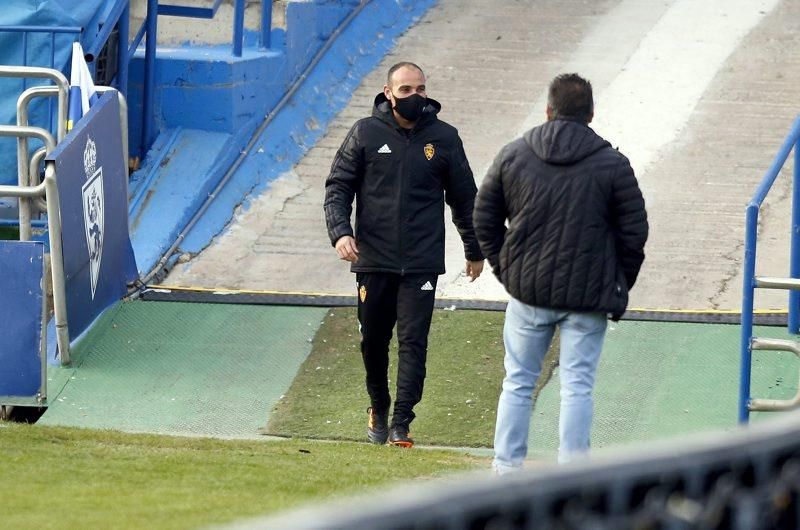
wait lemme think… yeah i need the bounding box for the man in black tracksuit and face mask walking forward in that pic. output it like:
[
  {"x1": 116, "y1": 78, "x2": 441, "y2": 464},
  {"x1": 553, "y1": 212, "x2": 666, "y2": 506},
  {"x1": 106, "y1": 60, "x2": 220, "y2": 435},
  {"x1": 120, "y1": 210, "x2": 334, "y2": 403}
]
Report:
[{"x1": 324, "y1": 62, "x2": 483, "y2": 447}]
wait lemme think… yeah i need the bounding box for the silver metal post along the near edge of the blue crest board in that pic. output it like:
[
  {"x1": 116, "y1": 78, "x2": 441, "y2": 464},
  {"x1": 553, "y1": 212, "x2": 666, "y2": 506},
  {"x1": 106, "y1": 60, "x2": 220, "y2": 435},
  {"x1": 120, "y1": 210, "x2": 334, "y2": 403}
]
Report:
[{"x1": 44, "y1": 161, "x2": 70, "y2": 365}]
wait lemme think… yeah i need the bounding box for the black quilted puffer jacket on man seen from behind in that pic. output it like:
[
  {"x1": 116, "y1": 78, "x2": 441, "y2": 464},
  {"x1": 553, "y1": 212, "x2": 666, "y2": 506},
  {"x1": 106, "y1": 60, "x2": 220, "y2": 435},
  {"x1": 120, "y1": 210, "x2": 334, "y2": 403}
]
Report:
[{"x1": 474, "y1": 119, "x2": 648, "y2": 319}]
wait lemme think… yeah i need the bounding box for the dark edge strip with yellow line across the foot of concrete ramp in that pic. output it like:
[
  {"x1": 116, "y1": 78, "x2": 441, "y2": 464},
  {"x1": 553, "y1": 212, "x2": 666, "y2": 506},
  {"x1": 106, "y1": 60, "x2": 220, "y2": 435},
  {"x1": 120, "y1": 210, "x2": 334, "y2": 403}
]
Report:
[{"x1": 140, "y1": 287, "x2": 787, "y2": 326}]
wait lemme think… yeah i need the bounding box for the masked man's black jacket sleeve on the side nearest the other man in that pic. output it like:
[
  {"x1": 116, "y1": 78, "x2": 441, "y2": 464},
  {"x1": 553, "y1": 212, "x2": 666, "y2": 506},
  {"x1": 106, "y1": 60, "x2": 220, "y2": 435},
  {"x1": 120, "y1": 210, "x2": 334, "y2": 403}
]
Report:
[{"x1": 444, "y1": 134, "x2": 483, "y2": 261}]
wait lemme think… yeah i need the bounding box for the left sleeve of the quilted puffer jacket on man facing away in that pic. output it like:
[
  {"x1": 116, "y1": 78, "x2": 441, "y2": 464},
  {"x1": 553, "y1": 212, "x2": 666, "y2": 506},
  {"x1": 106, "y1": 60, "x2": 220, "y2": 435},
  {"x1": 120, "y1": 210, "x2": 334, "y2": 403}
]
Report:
[{"x1": 473, "y1": 144, "x2": 508, "y2": 278}]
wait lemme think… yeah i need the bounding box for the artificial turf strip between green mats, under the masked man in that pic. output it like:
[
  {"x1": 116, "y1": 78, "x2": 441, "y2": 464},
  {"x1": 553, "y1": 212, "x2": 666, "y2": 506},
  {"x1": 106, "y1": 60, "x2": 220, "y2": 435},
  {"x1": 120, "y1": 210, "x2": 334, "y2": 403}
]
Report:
[{"x1": 267, "y1": 308, "x2": 554, "y2": 447}]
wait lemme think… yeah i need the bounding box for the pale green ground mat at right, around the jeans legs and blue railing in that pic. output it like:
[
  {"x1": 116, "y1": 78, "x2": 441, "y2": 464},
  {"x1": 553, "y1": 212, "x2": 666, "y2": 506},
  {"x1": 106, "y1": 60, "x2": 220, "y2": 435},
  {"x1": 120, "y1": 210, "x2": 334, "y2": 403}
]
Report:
[{"x1": 530, "y1": 321, "x2": 800, "y2": 458}]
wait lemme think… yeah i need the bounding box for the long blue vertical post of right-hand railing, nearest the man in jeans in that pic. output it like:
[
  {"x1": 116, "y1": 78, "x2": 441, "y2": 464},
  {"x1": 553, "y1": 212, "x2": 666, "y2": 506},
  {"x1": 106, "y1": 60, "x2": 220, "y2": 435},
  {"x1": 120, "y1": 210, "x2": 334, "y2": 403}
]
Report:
[{"x1": 739, "y1": 202, "x2": 758, "y2": 423}]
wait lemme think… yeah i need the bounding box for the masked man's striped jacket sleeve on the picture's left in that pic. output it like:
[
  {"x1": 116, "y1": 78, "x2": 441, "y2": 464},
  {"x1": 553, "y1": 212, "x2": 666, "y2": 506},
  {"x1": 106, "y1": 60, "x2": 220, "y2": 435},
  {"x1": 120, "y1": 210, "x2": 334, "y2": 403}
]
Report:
[{"x1": 323, "y1": 122, "x2": 364, "y2": 246}]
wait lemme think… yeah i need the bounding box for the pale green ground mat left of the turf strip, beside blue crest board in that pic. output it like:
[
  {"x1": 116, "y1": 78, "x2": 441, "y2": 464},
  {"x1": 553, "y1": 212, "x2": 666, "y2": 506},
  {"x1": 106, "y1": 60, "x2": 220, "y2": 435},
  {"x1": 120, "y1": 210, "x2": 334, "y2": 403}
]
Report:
[{"x1": 40, "y1": 301, "x2": 327, "y2": 438}]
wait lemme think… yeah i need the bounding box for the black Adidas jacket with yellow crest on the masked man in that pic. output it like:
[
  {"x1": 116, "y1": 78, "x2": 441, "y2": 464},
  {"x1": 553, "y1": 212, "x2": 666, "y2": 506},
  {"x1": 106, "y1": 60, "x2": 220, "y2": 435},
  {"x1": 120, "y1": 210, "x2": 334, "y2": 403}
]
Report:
[{"x1": 324, "y1": 93, "x2": 483, "y2": 274}]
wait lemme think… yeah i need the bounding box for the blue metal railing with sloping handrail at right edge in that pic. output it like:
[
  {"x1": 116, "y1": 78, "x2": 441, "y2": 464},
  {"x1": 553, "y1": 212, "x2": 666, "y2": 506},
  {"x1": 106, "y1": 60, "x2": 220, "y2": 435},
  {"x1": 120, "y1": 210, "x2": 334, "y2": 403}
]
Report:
[{"x1": 739, "y1": 117, "x2": 800, "y2": 423}]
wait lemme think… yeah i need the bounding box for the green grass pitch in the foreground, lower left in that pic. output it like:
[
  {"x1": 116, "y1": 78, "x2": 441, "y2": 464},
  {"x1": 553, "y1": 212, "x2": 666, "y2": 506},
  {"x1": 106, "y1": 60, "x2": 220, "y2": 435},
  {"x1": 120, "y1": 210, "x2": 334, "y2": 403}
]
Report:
[{"x1": 0, "y1": 423, "x2": 489, "y2": 528}]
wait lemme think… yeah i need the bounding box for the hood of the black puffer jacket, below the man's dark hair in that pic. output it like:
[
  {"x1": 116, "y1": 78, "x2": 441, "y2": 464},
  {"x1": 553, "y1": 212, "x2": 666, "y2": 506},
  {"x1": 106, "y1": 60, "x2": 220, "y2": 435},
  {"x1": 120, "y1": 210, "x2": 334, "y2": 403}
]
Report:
[{"x1": 523, "y1": 119, "x2": 611, "y2": 165}]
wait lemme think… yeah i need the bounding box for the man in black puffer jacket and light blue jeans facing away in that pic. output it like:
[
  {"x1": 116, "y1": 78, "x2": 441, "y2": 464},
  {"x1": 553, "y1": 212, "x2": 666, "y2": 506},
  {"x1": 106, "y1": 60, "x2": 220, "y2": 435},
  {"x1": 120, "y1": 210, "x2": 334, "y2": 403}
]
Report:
[{"x1": 474, "y1": 74, "x2": 648, "y2": 474}]
